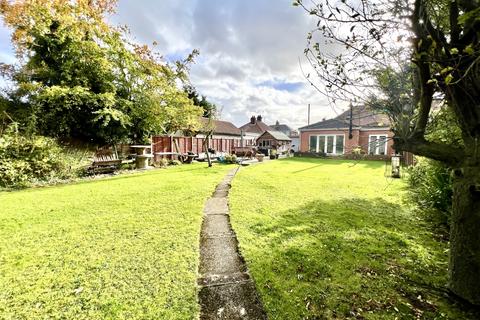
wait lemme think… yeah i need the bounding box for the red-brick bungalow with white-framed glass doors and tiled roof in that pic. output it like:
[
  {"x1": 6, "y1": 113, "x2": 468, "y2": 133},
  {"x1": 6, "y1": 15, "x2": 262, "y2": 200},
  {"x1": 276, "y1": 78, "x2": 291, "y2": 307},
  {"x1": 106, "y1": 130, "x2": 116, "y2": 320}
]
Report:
[{"x1": 299, "y1": 106, "x2": 394, "y2": 158}]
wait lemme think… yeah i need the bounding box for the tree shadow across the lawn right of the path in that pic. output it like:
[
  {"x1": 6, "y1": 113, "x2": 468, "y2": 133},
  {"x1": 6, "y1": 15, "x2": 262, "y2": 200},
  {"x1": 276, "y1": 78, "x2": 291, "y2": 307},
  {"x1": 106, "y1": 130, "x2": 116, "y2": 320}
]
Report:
[{"x1": 240, "y1": 198, "x2": 480, "y2": 319}]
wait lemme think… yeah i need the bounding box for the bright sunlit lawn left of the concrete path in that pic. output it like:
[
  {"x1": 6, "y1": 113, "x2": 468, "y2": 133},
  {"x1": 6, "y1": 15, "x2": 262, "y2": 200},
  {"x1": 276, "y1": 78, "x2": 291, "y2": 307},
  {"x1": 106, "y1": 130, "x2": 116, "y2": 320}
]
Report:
[{"x1": 0, "y1": 164, "x2": 230, "y2": 319}]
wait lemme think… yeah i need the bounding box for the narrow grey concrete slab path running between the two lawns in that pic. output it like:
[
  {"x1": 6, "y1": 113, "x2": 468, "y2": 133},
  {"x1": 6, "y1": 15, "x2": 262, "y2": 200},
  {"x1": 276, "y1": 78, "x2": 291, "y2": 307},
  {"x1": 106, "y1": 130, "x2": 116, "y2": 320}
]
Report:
[{"x1": 198, "y1": 168, "x2": 267, "y2": 320}]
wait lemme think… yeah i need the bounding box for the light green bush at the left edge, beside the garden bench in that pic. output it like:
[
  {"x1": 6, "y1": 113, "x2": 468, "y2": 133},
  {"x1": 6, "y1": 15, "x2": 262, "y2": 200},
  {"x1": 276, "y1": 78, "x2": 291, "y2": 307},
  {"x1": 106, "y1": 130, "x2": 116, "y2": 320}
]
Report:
[{"x1": 0, "y1": 124, "x2": 85, "y2": 188}]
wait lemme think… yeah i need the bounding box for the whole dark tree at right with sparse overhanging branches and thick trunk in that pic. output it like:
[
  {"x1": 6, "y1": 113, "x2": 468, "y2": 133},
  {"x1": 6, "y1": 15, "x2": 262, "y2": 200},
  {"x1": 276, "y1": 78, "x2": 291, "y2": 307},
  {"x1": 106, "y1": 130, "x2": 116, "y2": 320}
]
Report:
[{"x1": 294, "y1": 0, "x2": 480, "y2": 305}]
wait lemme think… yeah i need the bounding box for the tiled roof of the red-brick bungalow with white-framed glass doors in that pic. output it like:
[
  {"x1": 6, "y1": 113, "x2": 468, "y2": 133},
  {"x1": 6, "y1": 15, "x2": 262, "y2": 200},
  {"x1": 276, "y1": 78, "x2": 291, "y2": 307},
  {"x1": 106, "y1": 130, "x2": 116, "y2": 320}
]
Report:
[{"x1": 300, "y1": 106, "x2": 390, "y2": 130}]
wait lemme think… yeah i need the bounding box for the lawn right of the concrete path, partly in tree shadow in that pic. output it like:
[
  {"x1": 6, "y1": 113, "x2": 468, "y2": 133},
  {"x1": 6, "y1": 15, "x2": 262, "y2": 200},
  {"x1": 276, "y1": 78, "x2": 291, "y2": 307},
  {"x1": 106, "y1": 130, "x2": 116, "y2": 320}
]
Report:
[{"x1": 230, "y1": 159, "x2": 479, "y2": 319}]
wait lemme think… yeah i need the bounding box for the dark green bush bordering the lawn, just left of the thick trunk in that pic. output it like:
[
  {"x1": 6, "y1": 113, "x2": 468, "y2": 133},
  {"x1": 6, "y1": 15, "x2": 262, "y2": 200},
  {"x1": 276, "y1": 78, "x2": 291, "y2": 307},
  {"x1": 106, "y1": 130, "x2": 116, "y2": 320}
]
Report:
[{"x1": 407, "y1": 158, "x2": 453, "y2": 225}]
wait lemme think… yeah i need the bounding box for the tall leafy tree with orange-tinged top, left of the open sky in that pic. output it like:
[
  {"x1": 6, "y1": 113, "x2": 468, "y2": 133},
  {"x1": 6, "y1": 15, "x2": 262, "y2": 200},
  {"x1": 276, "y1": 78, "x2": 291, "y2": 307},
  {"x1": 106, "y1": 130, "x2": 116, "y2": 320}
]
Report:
[{"x1": 0, "y1": 0, "x2": 200, "y2": 144}]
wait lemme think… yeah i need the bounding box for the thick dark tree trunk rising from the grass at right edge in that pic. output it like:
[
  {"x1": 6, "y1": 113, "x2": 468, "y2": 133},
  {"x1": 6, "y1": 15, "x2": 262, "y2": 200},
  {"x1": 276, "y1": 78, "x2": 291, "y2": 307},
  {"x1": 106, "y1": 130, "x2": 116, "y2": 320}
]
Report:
[{"x1": 449, "y1": 165, "x2": 480, "y2": 305}]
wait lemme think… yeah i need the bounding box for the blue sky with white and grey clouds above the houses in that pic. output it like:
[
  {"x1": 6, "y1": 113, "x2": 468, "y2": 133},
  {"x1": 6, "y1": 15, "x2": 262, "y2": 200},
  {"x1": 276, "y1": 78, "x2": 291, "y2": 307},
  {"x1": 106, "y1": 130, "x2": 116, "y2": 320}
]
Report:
[{"x1": 0, "y1": 0, "x2": 342, "y2": 129}]
